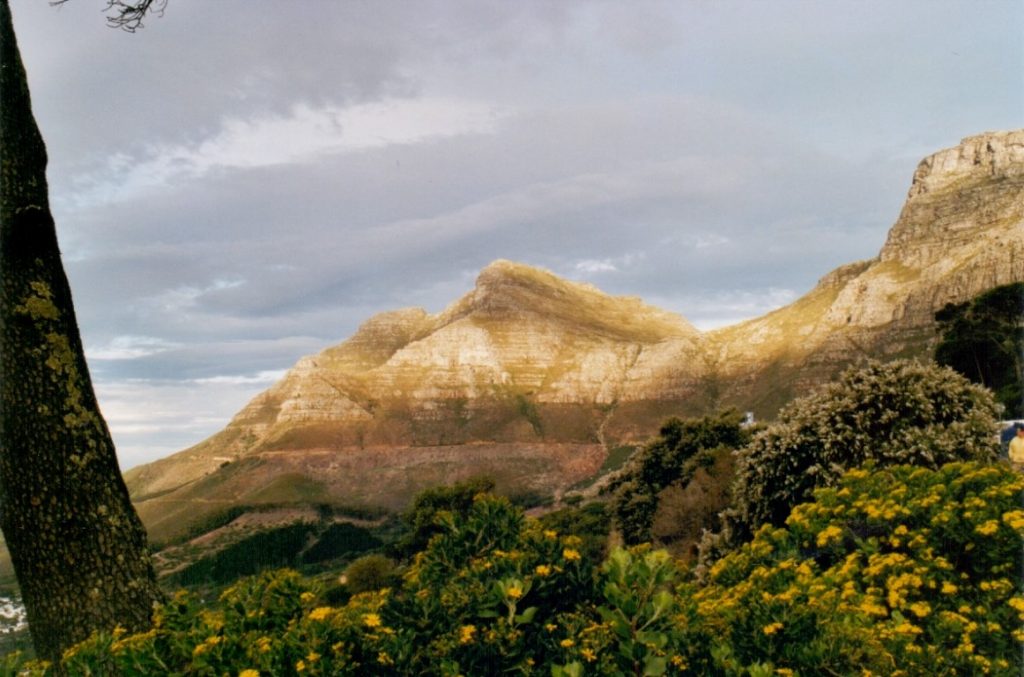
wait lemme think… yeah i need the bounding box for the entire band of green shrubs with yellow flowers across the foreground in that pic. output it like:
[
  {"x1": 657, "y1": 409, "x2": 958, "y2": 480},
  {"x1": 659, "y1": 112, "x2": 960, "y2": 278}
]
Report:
[{"x1": 7, "y1": 463, "x2": 1024, "y2": 677}]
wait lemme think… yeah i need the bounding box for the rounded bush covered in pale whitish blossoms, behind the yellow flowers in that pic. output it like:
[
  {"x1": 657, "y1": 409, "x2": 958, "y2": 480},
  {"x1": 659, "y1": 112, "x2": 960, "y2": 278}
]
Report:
[{"x1": 727, "y1": 361, "x2": 998, "y2": 543}]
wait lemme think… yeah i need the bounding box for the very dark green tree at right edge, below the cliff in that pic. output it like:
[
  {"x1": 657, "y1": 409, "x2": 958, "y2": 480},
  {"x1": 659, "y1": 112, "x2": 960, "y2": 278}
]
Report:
[{"x1": 935, "y1": 283, "x2": 1024, "y2": 418}]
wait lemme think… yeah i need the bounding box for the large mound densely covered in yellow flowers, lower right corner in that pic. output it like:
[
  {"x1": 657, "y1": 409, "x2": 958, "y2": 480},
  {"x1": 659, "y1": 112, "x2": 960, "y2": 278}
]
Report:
[{"x1": 687, "y1": 463, "x2": 1024, "y2": 675}]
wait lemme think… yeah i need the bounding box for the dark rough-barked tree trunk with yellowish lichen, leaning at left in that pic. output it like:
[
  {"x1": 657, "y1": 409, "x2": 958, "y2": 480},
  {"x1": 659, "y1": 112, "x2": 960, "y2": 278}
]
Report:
[{"x1": 0, "y1": 0, "x2": 161, "y2": 662}]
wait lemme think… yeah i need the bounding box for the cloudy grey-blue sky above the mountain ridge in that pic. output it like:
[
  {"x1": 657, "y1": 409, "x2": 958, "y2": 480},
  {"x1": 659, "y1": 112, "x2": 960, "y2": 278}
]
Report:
[{"x1": 11, "y1": 0, "x2": 1024, "y2": 467}]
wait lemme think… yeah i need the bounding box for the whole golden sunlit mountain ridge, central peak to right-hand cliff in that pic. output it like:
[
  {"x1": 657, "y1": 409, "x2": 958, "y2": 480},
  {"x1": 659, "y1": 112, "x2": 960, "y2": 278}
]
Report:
[{"x1": 126, "y1": 130, "x2": 1024, "y2": 542}]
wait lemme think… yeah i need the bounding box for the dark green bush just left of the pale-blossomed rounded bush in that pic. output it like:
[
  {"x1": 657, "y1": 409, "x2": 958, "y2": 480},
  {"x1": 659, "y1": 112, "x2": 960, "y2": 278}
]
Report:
[{"x1": 609, "y1": 410, "x2": 750, "y2": 545}]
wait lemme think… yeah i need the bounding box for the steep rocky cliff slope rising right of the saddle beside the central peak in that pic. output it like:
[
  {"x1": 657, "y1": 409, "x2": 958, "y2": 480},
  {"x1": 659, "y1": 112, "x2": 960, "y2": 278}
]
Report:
[{"x1": 708, "y1": 130, "x2": 1024, "y2": 415}]
